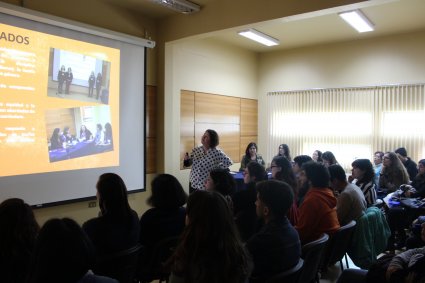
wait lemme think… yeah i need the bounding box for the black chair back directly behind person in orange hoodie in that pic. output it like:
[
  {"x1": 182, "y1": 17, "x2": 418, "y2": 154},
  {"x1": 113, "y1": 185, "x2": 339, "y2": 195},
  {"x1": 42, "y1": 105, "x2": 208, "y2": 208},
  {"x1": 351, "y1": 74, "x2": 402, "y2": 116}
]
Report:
[{"x1": 298, "y1": 233, "x2": 329, "y2": 283}]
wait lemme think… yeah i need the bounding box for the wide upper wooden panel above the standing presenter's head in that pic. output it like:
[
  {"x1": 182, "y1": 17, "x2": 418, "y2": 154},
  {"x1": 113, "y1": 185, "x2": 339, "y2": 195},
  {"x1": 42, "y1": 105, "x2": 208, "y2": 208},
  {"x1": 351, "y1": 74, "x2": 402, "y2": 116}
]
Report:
[{"x1": 195, "y1": 92, "x2": 240, "y2": 124}]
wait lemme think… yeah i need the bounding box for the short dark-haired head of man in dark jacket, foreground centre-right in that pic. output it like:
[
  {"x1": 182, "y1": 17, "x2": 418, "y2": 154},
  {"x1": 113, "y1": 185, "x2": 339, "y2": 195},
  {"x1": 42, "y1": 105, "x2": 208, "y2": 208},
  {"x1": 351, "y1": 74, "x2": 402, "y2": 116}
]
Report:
[{"x1": 255, "y1": 180, "x2": 294, "y2": 223}]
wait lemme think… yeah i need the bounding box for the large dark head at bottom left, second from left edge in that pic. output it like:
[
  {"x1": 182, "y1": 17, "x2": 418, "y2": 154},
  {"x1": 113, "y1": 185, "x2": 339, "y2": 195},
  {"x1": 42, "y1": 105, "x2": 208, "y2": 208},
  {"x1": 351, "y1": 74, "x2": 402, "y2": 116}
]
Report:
[{"x1": 29, "y1": 218, "x2": 94, "y2": 283}]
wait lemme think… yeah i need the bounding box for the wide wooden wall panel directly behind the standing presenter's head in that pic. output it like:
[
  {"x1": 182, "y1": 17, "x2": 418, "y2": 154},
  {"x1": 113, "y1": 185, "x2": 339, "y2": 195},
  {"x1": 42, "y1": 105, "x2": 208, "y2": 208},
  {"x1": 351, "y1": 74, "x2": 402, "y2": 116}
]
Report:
[{"x1": 195, "y1": 123, "x2": 240, "y2": 162}]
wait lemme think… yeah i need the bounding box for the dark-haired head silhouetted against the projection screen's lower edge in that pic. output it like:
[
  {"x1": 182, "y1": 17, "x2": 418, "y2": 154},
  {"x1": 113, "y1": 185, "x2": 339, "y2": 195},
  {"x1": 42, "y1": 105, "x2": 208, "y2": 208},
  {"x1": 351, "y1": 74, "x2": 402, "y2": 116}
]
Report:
[{"x1": 96, "y1": 173, "x2": 131, "y2": 216}]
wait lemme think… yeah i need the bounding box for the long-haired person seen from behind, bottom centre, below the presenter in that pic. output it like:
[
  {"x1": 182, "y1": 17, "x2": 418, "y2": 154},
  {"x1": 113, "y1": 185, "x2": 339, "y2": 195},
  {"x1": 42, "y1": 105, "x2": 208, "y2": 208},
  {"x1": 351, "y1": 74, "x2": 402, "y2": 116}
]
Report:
[{"x1": 167, "y1": 190, "x2": 251, "y2": 283}]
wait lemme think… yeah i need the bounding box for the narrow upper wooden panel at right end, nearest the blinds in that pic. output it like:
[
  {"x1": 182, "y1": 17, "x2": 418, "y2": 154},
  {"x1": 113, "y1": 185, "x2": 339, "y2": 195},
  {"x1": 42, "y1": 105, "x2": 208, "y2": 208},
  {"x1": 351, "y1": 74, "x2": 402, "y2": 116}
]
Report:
[{"x1": 241, "y1": 98, "x2": 258, "y2": 136}]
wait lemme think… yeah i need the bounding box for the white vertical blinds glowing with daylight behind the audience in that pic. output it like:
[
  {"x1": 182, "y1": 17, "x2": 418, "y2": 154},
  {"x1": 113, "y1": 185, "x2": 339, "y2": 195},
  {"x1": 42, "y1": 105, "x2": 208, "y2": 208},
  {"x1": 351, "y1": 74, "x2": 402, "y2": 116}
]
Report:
[{"x1": 267, "y1": 84, "x2": 425, "y2": 170}]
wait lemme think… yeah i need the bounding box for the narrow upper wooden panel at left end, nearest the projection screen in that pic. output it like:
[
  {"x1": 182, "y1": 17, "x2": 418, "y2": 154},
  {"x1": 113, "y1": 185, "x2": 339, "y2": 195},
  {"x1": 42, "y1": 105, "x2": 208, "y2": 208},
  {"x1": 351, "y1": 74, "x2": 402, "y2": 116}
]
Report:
[{"x1": 180, "y1": 90, "x2": 195, "y2": 136}]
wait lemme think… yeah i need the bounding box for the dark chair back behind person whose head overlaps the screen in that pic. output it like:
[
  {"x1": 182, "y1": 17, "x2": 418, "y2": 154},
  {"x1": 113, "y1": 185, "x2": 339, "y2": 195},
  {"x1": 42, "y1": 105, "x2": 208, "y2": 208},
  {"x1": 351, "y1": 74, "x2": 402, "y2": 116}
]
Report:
[{"x1": 93, "y1": 244, "x2": 142, "y2": 283}]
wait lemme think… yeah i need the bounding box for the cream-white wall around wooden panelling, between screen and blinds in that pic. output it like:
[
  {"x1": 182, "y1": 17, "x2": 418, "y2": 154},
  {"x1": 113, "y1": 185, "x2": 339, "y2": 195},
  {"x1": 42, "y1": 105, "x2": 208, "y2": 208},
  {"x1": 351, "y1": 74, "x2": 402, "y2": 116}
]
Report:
[{"x1": 164, "y1": 39, "x2": 258, "y2": 189}]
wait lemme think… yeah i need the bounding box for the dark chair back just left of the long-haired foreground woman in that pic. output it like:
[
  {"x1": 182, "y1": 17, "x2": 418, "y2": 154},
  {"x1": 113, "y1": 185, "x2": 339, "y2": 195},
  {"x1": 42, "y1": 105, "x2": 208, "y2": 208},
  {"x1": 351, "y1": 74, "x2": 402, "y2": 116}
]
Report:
[{"x1": 137, "y1": 236, "x2": 180, "y2": 283}]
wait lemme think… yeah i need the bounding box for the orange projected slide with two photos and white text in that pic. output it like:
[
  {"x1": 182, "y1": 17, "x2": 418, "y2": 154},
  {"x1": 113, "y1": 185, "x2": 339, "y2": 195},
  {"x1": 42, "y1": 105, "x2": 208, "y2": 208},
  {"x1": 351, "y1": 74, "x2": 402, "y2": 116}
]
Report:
[{"x1": 0, "y1": 24, "x2": 120, "y2": 176}]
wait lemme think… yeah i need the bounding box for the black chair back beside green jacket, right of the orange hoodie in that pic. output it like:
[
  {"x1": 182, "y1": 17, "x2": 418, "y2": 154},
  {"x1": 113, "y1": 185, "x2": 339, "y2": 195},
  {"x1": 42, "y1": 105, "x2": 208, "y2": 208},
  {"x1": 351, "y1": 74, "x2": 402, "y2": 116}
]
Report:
[{"x1": 323, "y1": 220, "x2": 356, "y2": 271}]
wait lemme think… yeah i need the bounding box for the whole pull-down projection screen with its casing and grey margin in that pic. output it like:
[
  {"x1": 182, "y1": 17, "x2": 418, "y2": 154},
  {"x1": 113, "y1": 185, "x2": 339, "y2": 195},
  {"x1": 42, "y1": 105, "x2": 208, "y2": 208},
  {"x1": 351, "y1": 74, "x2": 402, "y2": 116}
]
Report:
[{"x1": 0, "y1": 3, "x2": 155, "y2": 207}]
